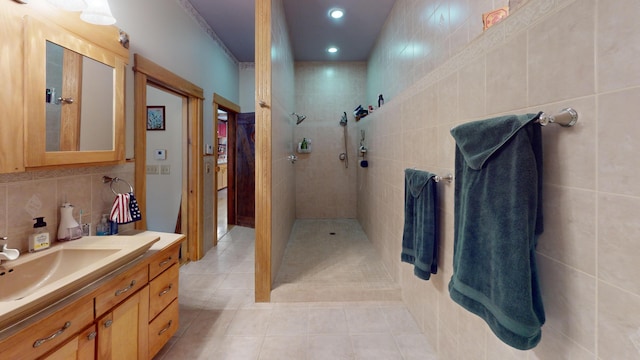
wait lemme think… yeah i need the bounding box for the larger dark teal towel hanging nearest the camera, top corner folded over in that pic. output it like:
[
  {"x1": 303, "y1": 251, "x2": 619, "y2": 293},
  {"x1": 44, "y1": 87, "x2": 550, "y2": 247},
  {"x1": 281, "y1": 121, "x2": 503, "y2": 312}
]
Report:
[{"x1": 449, "y1": 114, "x2": 545, "y2": 350}]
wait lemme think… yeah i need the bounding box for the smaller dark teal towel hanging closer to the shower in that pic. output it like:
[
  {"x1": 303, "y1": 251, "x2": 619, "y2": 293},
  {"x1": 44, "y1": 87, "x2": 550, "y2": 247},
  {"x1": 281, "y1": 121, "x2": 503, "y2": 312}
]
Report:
[{"x1": 400, "y1": 169, "x2": 438, "y2": 280}]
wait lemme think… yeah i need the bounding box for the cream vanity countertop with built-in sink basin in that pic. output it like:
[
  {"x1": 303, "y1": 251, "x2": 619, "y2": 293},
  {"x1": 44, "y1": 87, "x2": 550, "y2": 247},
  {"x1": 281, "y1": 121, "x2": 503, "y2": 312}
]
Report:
[{"x1": 0, "y1": 235, "x2": 159, "y2": 329}]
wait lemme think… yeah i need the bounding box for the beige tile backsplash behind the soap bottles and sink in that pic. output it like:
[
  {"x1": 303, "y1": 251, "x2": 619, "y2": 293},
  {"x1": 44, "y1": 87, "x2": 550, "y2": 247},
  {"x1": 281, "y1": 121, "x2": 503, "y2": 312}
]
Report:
[{"x1": 0, "y1": 163, "x2": 135, "y2": 252}]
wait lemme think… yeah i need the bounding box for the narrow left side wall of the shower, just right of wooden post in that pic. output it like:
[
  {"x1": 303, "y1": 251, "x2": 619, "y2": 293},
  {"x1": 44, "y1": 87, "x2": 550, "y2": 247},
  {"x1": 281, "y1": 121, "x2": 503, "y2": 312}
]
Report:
[{"x1": 270, "y1": 0, "x2": 296, "y2": 282}]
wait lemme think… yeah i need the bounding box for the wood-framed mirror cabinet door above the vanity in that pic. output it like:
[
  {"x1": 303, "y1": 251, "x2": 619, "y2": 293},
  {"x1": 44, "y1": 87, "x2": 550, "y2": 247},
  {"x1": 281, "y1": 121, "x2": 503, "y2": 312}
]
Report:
[{"x1": 24, "y1": 16, "x2": 128, "y2": 167}]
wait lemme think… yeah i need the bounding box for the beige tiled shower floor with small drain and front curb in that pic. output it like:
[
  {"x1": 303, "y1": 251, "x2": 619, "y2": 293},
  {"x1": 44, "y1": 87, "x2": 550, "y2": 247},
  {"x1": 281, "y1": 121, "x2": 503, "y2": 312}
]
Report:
[{"x1": 271, "y1": 219, "x2": 401, "y2": 302}]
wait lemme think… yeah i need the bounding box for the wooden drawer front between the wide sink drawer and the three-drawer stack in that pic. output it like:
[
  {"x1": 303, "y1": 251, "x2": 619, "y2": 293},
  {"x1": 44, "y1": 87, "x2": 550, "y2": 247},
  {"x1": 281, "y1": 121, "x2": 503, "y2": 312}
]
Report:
[{"x1": 95, "y1": 267, "x2": 149, "y2": 318}]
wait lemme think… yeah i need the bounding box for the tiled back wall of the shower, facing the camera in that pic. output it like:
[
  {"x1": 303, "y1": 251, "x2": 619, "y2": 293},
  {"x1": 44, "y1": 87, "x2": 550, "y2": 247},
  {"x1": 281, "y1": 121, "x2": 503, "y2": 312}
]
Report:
[{"x1": 294, "y1": 62, "x2": 367, "y2": 219}]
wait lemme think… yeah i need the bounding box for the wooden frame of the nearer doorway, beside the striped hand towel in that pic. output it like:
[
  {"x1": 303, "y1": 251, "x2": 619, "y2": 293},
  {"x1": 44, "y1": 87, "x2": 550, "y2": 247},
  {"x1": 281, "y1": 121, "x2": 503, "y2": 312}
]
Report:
[{"x1": 133, "y1": 54, "x2": 204, "y2": 260}]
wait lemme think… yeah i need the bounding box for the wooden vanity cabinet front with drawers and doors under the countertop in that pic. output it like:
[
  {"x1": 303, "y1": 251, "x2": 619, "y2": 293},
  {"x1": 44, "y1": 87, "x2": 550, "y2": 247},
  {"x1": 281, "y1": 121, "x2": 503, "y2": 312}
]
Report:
[{"x1": 0, "y1": 237, "x2": 184, "y2": 360}]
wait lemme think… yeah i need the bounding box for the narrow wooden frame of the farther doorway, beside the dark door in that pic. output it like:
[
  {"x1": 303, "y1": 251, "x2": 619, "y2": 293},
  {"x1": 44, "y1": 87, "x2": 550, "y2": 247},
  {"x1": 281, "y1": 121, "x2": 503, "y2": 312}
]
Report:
[{"x1": 213, "y1": 93, "x2": 240, "y2": 246}]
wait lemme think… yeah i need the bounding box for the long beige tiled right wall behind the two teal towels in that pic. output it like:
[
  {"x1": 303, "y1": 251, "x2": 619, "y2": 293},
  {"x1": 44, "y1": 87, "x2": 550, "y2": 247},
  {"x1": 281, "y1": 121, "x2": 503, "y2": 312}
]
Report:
[{"x1": 357, "y1": 0, "x2": 640, "y2": 359}]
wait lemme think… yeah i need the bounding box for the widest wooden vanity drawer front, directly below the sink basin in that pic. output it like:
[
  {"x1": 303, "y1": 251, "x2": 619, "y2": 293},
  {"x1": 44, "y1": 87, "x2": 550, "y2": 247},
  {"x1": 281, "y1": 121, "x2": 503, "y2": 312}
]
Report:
[{"x1": 0, "y1": 299, "x2": 93, "y2": 359}]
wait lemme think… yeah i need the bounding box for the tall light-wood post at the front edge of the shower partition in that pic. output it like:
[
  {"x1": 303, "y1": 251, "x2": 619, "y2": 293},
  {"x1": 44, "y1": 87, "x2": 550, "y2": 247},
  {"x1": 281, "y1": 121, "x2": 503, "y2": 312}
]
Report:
[{"x1": 255, "y1": 1, "x2": 272, "y2": 302}]
